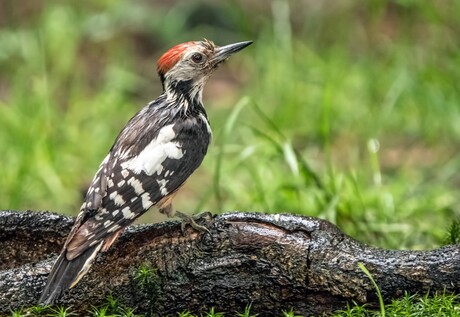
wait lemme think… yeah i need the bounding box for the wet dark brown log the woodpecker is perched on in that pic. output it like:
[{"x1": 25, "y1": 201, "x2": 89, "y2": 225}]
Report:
[{"x1": 0, "y1": 211, "x2": 460, "y2": 316}]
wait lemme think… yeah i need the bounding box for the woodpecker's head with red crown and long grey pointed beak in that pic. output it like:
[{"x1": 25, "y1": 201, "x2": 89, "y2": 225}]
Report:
[{"x1": 157, "y1": 39, "x2": 252, "y2": 99}]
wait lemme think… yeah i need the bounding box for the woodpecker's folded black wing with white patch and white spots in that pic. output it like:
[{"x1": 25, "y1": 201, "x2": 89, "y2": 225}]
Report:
[{"x1": 67, "y1": 118, "x2": 209, "y2": 258}]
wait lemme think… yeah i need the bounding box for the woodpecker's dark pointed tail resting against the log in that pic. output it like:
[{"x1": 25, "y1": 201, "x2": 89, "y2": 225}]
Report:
[{"x1": 38, "y1": 242, "x2": 102, "y2": 305}]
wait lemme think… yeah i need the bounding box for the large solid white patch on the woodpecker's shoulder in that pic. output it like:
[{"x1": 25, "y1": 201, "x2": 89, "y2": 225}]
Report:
[{"x1": 122, "y1": 124, "x2": 184, "y2": 176}]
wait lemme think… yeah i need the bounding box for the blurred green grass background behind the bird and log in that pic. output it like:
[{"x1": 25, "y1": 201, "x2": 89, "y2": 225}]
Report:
[{"x1": 0, "y1": 0, "x2": 460, "y2": 249}]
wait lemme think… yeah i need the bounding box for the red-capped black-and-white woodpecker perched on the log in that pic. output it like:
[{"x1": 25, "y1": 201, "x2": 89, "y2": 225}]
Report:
[{"x1": 39, "y1": 39, "x2": 252, "y2": 305}]
